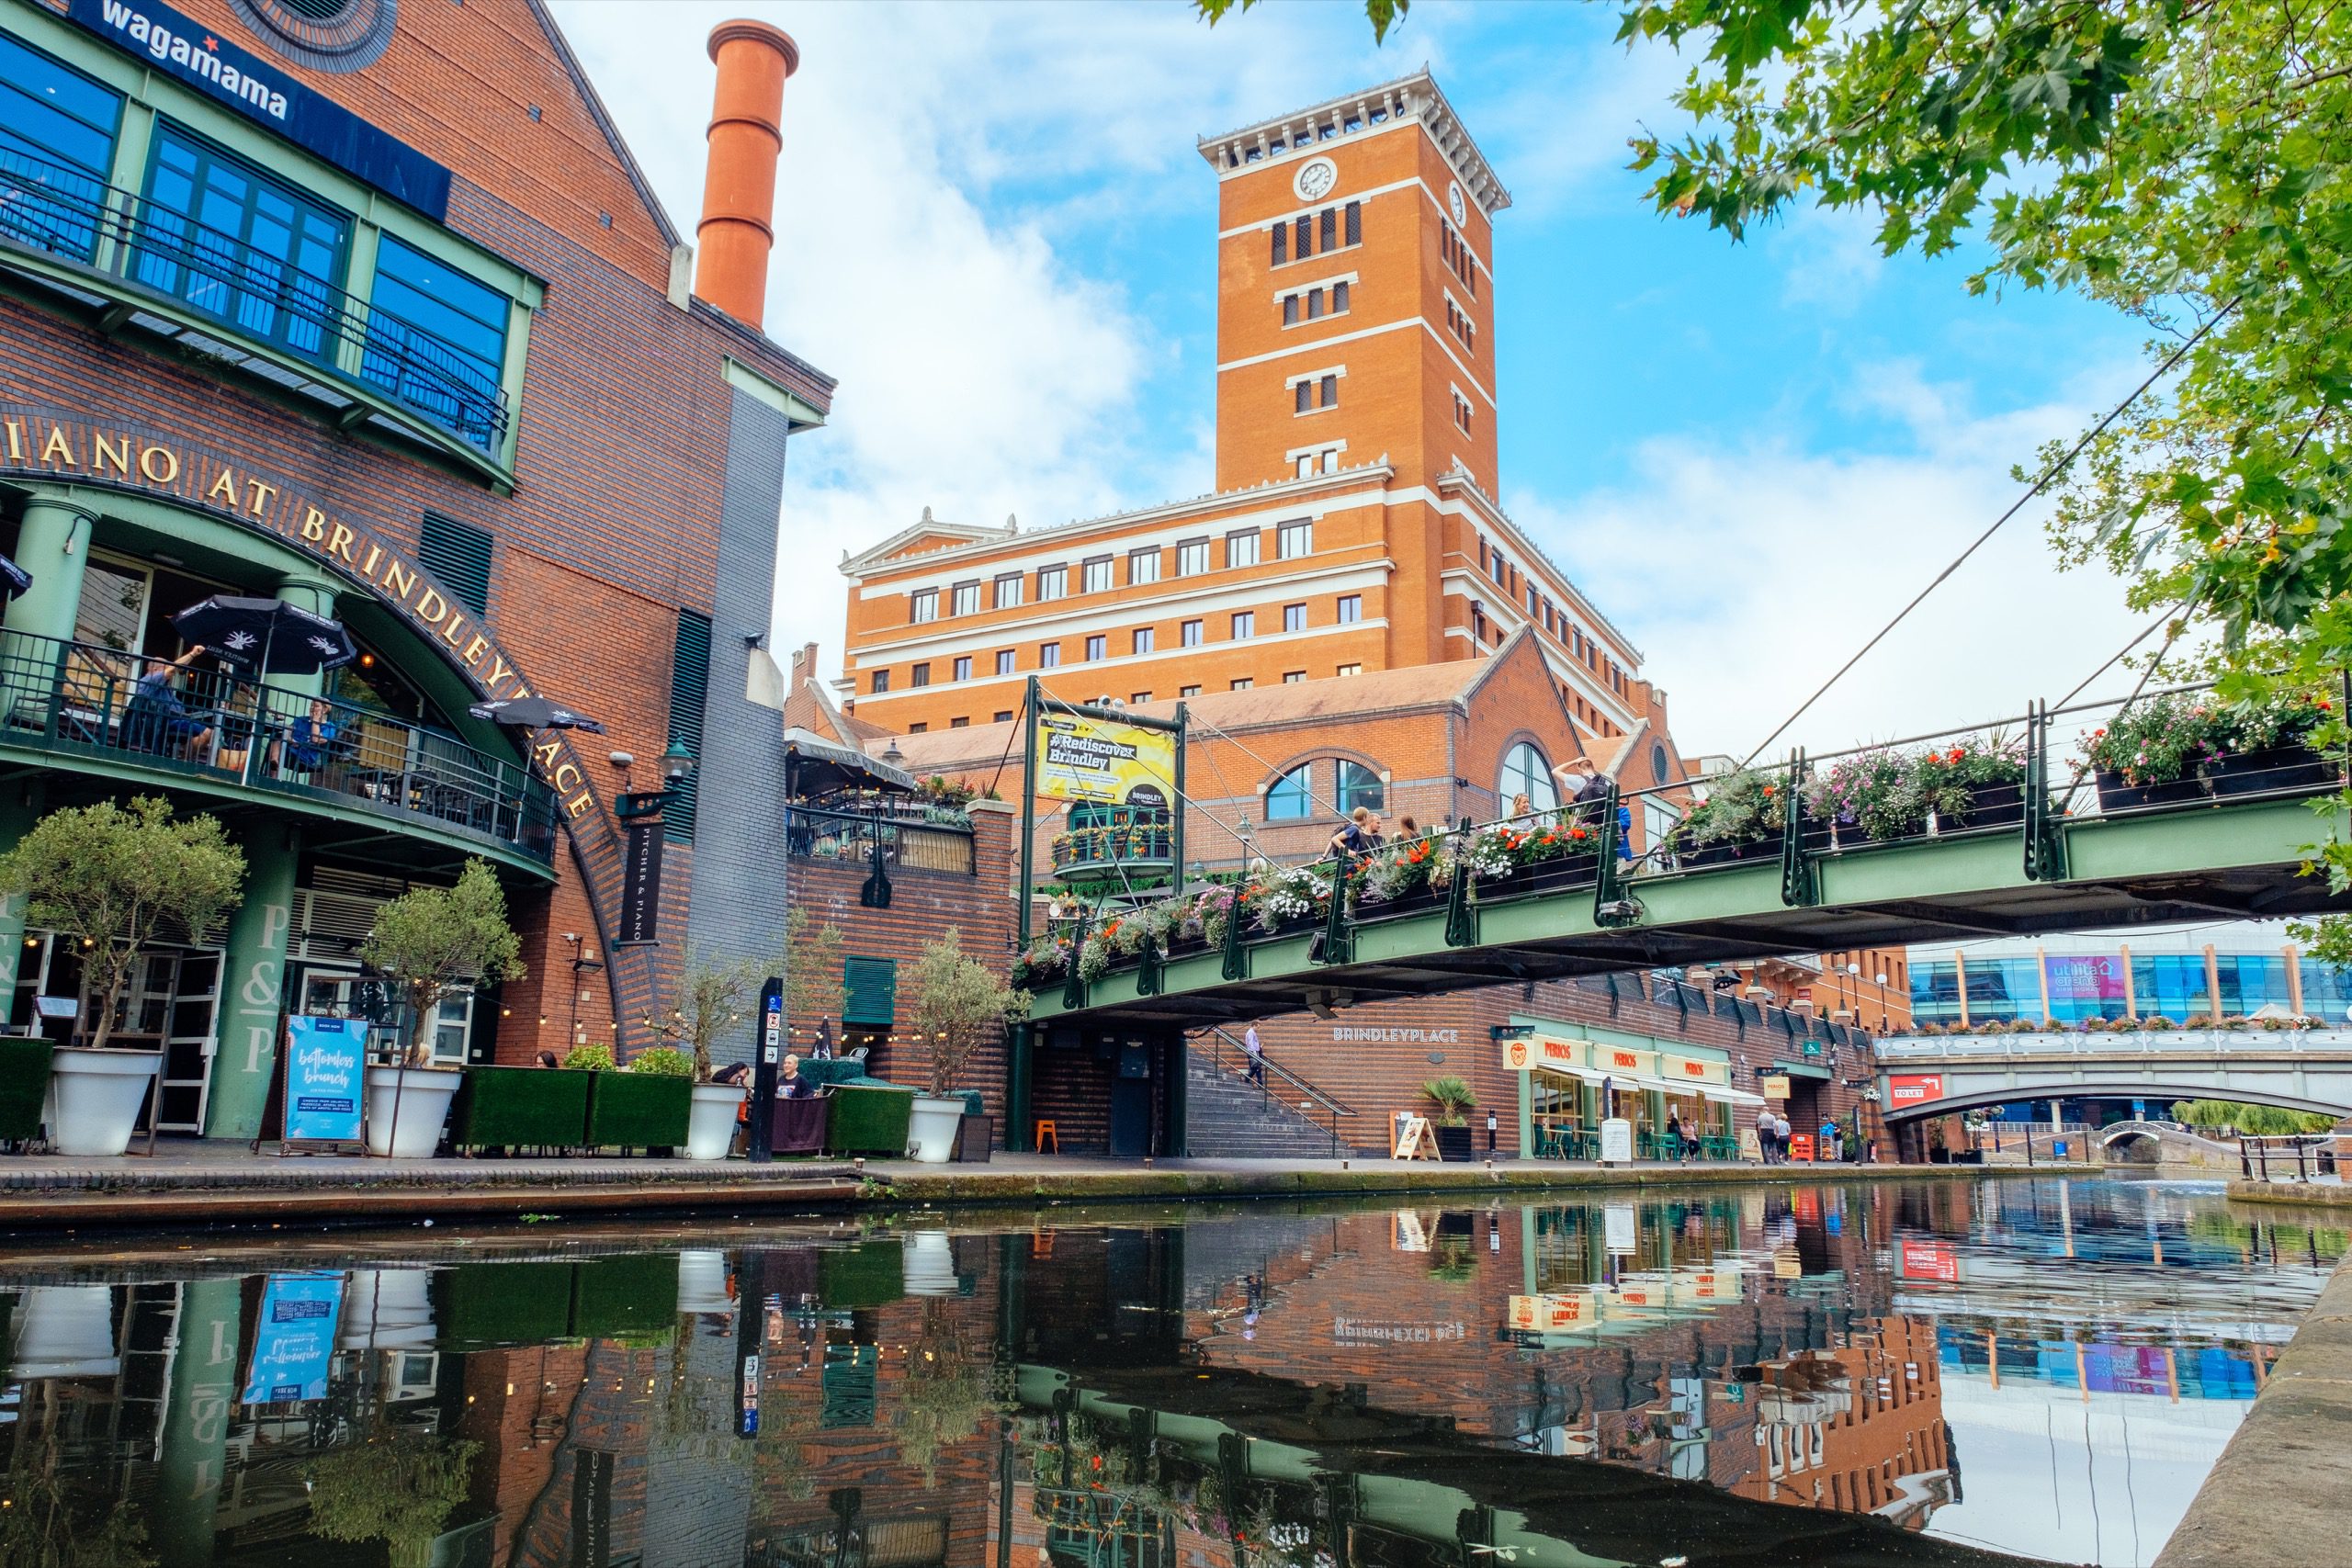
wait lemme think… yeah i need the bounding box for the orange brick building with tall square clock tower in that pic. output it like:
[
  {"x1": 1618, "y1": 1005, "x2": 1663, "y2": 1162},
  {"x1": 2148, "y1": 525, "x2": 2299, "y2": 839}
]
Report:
[{"x1": 842, "y1": 73, "x2": 1665, "y2": 761}]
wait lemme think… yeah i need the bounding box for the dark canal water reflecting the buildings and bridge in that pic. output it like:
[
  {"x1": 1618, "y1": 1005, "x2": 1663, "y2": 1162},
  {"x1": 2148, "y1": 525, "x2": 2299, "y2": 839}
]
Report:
[{"x1": 0, "y1": 1180, "x2": 2345, "y2": 1568}]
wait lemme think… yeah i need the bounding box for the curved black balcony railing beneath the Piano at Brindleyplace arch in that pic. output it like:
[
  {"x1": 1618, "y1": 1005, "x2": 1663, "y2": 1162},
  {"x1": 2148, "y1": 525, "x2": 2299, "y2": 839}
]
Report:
[{"x1": 0, "y1": 632, "x2": 555, "y2": 863}]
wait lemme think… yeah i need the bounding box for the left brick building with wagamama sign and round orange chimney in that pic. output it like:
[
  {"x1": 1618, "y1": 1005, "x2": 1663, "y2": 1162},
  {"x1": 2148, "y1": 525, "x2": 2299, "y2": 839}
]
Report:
[{"x1": 0, "y1": 0, "x2": 832, "y2": 1138}]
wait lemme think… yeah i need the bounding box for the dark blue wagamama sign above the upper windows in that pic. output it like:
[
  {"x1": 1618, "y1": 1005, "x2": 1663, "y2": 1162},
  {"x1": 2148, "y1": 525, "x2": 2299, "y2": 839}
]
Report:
[{"x1": 66, "y1": 0, "x2": 449, "y2": 223}]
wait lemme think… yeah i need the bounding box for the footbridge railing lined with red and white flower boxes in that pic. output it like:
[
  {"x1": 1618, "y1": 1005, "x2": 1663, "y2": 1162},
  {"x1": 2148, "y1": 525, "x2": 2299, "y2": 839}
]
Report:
[{"x1": 1018, "y1": 671, "x2": 2352, "y2": 991}]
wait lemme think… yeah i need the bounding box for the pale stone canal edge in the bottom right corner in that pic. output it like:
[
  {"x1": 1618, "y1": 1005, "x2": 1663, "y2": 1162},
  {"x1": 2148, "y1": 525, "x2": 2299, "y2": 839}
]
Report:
[{"x1": 2157, "y1": 1250, "x2": 2352, "y2": 1568}]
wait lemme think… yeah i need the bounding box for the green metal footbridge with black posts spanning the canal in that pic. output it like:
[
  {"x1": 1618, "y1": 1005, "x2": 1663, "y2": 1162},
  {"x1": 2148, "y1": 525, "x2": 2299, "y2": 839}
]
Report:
[{"x1": 1030, "y1": 710, "x2": 2352, "y2": 1032}]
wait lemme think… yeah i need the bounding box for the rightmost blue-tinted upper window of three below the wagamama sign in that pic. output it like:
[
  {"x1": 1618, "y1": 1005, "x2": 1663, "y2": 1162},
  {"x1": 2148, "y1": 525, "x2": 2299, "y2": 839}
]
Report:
[{"x1": 360, "y1": 235, "x2": 511, "y2": 446}]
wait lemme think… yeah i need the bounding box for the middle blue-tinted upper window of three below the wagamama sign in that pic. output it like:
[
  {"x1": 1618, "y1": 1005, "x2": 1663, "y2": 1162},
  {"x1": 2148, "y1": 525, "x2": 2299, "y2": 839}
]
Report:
[{"x1": 131, "y1": 125, "x2": 350, "y2": 360}]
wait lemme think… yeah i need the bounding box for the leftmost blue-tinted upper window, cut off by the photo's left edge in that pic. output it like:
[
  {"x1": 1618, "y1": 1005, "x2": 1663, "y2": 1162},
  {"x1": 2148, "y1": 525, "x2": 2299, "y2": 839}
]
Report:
[{"x1": 0, "y1": 33, "x2": 122, "y2": 261}]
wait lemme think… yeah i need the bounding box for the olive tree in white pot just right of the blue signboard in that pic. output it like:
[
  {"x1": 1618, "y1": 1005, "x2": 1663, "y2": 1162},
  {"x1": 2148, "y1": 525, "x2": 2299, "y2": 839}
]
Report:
[{"x1": 360, "y1": 861, "x2": 522, "y2": 1159}]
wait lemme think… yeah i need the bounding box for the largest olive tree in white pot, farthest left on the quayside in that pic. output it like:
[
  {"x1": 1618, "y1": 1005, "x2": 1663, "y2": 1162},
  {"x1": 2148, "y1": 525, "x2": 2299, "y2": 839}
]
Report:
[{"x1": 0, "y1": 795, "x2": 244, "y2": 1155}]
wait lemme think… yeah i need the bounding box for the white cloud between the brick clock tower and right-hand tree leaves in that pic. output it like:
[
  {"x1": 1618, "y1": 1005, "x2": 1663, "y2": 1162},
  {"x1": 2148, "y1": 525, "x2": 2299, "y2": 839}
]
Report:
[{"x1": 1512, "y1": 365, "x2": 2143, "y2": 755}]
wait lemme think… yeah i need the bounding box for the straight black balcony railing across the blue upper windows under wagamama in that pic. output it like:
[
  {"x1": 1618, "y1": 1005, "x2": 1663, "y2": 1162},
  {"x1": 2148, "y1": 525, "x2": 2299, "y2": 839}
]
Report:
[{"x1": 0, "y1": 148, "x2": 508, "y2": 451}]
